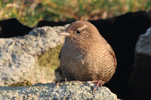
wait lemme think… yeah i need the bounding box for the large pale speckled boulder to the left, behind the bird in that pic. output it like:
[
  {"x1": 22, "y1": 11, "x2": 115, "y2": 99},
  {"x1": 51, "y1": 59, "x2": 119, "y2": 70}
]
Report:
[{"x1": 0, "y1": 26, "x2": 67, "y2": 86}]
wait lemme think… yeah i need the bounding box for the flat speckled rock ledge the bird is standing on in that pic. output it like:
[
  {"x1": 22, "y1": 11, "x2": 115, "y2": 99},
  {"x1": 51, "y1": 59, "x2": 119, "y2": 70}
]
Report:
[{"x1": 0, "y1": 81, "x2": 119, "y2": 100}]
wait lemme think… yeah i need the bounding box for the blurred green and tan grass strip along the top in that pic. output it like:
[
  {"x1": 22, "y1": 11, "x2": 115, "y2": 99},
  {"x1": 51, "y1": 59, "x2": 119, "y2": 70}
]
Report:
[{"x1": 0, "y1": 0, "x2": 151, "y2": 27}]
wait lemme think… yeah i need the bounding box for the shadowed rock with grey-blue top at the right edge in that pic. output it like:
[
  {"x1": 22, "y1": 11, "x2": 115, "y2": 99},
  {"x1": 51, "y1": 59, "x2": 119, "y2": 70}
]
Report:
[{"x1": 129, "y1": 28, "x2": 151, "y2": 100}]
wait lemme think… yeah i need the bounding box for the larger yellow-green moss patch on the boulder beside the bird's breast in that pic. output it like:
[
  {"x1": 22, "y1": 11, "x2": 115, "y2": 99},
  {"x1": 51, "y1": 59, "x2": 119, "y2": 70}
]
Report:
[{"x1": 38, "y1": 45, "x2": 62, "y2": 70}]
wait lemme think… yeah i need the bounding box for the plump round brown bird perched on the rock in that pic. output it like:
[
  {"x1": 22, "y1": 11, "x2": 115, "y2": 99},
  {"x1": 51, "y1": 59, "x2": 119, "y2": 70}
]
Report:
[{"x1": 59, "y1": 21, "x2": 117, "y2": 88}]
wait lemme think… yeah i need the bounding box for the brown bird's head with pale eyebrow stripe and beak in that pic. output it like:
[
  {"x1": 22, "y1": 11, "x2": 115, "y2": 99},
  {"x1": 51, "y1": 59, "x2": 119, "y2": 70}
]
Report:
[{"x1": 60, "y1": 21, "x2": 100, "y2": 42}]
